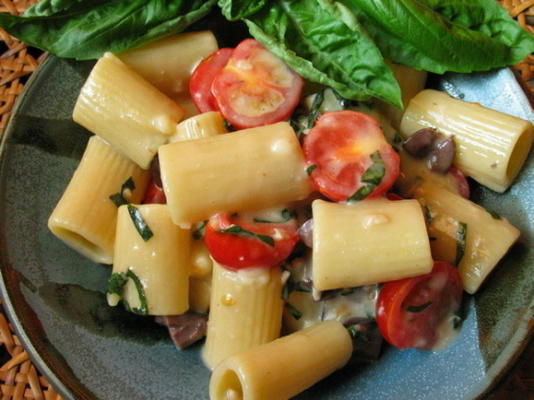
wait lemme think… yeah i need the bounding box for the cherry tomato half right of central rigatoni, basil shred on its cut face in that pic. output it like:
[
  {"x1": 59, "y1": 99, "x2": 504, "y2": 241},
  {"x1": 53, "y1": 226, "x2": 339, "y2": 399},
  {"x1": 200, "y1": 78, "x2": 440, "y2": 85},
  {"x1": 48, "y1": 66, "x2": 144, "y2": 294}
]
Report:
[{"x1": 303, "y1": 111, "x2": 400, "y2": 201}]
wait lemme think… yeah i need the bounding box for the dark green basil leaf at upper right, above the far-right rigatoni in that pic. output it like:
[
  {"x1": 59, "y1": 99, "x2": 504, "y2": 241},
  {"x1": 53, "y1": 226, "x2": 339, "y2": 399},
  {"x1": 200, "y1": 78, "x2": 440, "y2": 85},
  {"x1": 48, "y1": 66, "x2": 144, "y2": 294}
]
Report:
[{"x1": 341, "y1": 0, "x2": 534, "y2": 73}]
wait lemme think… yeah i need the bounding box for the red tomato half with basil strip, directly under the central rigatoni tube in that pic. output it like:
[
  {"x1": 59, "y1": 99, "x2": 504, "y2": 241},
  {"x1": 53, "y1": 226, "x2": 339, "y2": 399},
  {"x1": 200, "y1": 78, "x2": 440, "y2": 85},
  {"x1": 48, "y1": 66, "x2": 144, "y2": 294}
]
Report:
[{"x1": 204, "y1": 214, "x2": 299, "y2": 269}]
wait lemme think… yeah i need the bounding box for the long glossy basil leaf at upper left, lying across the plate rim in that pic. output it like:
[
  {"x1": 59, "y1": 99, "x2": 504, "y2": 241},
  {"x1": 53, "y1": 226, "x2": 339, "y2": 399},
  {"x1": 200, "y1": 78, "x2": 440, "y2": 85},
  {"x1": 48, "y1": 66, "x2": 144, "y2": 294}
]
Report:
[{"x1": 0, "y1": 0, "x2": 216, "y2": 60}]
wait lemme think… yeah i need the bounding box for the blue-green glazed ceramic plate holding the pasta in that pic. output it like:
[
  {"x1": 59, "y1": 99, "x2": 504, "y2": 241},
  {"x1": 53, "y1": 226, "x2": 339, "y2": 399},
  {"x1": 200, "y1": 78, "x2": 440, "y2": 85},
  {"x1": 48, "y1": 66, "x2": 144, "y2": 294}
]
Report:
[{"x1": 0, "y1": 30, "x2": 534, "y2": 400}]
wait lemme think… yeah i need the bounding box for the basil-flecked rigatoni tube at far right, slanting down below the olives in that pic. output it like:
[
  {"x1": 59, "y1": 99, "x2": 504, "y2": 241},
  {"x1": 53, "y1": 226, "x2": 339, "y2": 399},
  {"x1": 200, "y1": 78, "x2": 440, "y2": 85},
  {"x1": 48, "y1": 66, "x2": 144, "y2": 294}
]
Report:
[{"x1": 414, "y1": 183, "x2": 520, "y2": 294}]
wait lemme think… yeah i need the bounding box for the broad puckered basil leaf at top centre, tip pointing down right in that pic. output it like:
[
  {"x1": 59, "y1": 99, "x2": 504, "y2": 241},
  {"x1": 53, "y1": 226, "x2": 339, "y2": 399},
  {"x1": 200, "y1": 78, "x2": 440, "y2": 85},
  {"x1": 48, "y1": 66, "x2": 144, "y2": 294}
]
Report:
[{"x1": 245, "y1": 0, "x2": 402, "y2": 107}]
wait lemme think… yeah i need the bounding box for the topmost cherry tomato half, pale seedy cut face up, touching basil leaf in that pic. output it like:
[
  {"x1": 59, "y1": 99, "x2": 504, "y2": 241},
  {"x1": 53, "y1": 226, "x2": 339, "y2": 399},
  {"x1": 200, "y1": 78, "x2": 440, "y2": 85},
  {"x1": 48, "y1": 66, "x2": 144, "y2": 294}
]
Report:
[{"x1": 211, "y1": 39, "x2": 304, "y2": 129}]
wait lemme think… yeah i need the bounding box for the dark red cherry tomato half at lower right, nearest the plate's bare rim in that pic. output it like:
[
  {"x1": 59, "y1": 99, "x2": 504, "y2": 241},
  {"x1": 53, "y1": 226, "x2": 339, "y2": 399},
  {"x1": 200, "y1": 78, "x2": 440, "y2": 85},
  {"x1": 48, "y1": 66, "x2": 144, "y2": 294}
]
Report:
[{"x1": 376, "y1": 261, "x2": 463, "y2": 350}]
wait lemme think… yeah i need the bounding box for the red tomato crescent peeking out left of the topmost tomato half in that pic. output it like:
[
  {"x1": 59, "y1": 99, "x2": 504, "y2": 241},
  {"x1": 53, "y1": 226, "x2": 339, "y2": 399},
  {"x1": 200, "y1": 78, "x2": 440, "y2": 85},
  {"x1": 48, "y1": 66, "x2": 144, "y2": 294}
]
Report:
[{"x1": 189, "y1": 47, "x2": 234, "y2": 113}]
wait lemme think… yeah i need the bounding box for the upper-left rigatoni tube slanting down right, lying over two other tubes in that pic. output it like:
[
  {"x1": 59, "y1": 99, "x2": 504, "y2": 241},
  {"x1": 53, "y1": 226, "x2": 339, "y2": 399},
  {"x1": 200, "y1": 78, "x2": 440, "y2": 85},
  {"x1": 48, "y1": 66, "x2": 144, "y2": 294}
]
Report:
[{"x1": 72, "y1": 53, "x2": 184, "y2": 169}]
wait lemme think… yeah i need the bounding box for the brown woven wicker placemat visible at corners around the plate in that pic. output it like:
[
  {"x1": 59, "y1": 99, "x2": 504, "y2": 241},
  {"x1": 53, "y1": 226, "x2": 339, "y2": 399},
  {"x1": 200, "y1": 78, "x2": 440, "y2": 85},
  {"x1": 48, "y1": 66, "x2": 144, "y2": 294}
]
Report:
[{"x1": 0, "y1": 0, "x2": 534, "y2": 400}]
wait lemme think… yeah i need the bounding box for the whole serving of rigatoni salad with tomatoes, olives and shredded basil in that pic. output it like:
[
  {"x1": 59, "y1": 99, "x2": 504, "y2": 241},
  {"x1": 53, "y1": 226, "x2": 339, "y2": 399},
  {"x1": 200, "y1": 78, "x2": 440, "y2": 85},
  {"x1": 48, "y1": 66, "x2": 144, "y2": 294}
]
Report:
[{"x1": 44, "y1": 31, "x2": 534, "y2": 399}]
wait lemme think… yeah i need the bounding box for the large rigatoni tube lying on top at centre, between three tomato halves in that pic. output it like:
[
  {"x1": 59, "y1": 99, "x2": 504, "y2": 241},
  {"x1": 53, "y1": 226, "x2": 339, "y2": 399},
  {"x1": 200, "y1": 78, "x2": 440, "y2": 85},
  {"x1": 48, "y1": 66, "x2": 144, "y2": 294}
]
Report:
[{"x1": 159, "y1": 122, "x2": 311, "y2": 226}]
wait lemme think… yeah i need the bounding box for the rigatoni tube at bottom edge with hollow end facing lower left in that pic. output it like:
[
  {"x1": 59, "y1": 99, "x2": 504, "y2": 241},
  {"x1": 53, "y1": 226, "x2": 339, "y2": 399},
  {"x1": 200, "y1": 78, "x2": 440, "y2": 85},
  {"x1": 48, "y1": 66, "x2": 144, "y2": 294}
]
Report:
[{"x1": 210, "y1": 321, "x2": 352, "y2": 400}]
